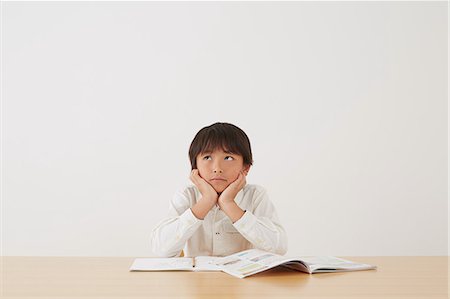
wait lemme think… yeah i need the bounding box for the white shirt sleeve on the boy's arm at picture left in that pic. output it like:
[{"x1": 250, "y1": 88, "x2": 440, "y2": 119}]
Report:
[{"x1": 150, "y1": 190, "x2": 203, "y2": 257}]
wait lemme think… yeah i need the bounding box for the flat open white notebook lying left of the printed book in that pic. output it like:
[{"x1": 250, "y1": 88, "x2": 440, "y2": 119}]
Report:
[{"x1": 130, "y1": 256, "x2": 222, "y2": 271}]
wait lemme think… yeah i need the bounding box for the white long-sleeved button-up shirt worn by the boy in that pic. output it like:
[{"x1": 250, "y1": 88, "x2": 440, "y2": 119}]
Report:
[{"x1": 150, "y1": 184, "x2": 287, "y2": 257}]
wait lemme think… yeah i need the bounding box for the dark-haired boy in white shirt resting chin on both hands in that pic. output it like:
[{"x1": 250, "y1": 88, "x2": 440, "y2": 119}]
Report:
[{"x1": 150, "y1": 123, "x2": 287, "y2": 257}]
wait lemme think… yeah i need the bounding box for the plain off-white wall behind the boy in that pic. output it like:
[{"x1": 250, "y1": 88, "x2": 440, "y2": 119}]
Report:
[{"x1": 1, "y1": 2, "x2": 448, "y2": 256}]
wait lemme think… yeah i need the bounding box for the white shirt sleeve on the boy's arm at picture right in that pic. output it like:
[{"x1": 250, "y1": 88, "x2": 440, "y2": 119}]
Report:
[{"x1": 233, "y1": 188, "x2": 287, "y2": 255}]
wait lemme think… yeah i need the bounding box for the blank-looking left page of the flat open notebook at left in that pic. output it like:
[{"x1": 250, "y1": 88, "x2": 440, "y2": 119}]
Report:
[{"x1": 130, "y1": 257, "x2": 193, "y2": 271}]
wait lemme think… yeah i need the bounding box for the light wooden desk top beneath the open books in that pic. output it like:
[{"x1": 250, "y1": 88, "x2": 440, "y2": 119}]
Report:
[{"x1": 1, "y1": 256, "x2": 448, "y2": 299}]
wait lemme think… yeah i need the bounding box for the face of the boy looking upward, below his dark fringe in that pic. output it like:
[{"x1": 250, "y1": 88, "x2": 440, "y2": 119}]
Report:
[{"x1": 197, "y1": 149, "x2": 250, "y2": 193}]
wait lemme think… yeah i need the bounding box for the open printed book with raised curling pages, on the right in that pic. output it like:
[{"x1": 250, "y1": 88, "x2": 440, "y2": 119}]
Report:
[{"x1": 213, "y1": 249, "x2": 376, "y2": 278}]
